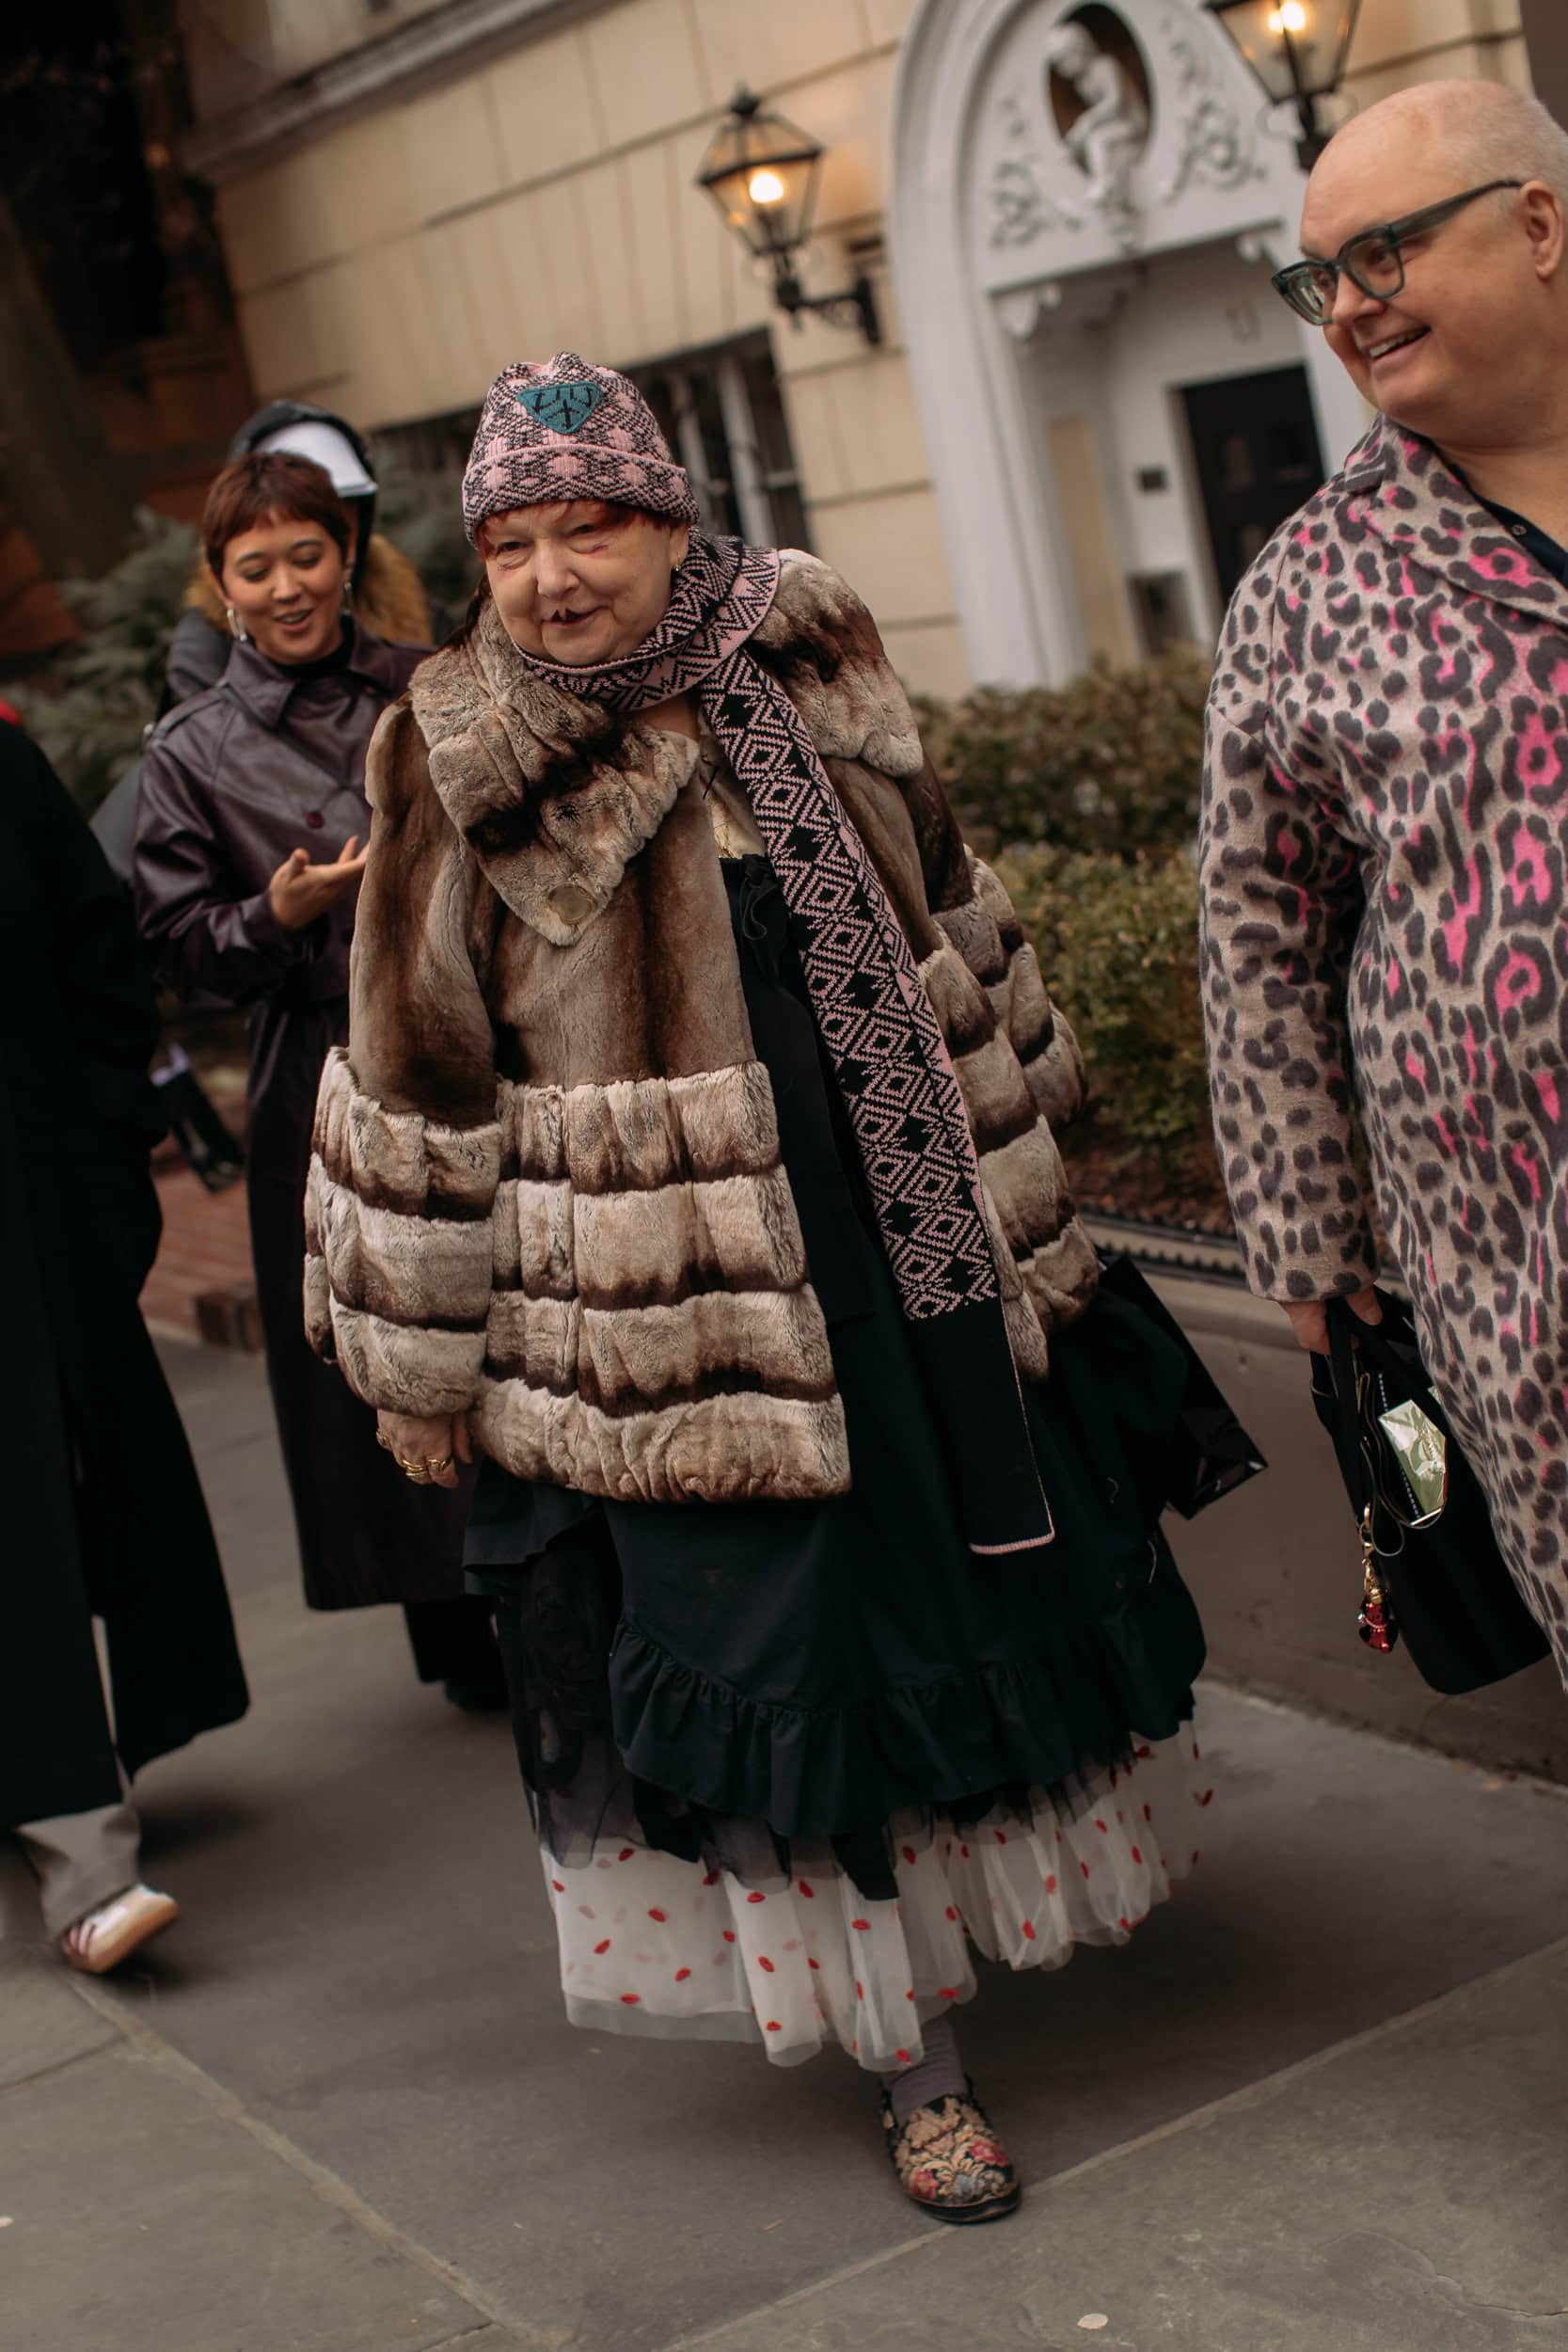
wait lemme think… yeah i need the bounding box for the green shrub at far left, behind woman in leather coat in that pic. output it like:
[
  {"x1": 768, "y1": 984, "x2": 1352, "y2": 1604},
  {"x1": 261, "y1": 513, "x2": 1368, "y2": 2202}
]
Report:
[{"x1": 11, "y1": 506, "x2": 198, "y2": 817}]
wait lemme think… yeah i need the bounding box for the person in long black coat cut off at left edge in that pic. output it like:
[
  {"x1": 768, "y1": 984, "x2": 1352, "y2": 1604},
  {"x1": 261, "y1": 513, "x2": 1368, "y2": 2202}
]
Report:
[{"x1": 0, "y1": 724, "x2": 249, "y2": 1974}]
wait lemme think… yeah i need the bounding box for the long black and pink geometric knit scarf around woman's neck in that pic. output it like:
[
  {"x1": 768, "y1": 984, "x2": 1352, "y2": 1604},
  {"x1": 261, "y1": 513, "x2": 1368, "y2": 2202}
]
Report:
[{"x1": 519, "y1": 530, "x2": 1051, "y2": 1552}]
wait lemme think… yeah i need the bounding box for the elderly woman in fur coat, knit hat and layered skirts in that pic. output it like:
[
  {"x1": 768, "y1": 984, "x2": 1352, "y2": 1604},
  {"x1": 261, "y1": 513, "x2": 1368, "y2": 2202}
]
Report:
[{"x1": 308, "y1": 353, "x2": 1204, "y2": 2220}]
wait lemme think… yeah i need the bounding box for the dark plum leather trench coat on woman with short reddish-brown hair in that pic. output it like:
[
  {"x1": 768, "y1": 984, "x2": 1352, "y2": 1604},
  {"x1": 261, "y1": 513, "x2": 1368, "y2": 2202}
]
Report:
[{"x1": 136, "y1": 624, "x2": 467, "y2": 1609}]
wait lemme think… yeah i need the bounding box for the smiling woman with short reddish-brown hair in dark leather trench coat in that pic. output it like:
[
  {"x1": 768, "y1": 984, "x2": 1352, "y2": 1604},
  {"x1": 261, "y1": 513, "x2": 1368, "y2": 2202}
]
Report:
[{"x1": 136, "y1": 452, "x2": 499, "y2": 1703}]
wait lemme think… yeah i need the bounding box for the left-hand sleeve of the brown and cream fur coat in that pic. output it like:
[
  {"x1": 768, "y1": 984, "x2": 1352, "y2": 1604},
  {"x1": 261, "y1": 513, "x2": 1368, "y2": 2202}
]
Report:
[{"x1": 306, "y1": 704, "x2": 500, "y2": 1416}]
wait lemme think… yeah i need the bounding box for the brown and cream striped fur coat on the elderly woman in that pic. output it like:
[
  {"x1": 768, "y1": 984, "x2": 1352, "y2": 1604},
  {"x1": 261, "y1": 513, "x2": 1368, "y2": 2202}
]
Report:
[{"x1": 306, "y1": 555, "x2": 1096, "y2": 1503}]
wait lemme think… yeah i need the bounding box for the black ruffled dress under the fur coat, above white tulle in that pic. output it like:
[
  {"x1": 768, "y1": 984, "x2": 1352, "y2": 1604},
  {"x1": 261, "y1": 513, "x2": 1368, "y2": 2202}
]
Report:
[{"x1": 466, "y1": 859, "x2": 1204, "y2": 1899}]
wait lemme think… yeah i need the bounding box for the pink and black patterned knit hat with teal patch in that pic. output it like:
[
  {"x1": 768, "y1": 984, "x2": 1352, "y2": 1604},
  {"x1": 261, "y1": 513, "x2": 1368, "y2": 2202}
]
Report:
[{"x1": 463, "y1": 351, "x2": 698, "y2": 541}]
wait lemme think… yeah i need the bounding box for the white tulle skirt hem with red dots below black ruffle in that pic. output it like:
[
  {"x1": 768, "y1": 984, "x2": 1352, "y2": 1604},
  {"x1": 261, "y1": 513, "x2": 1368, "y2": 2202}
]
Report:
[{"x1": 543, "y1": 1726, "x2": 1213, "y2": 2073}]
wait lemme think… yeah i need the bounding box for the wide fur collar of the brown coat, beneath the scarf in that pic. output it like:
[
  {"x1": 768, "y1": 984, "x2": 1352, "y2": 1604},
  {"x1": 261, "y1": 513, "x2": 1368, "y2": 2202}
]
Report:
[{"x1": 409, "y1": 553, "x2": 922, "y2": 948}]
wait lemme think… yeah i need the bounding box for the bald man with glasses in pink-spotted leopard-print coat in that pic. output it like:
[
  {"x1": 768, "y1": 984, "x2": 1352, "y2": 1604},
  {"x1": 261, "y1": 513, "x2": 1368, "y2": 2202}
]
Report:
[{"x1": 1201, "y1": 83, "x2": 1568, "y2": 1682}]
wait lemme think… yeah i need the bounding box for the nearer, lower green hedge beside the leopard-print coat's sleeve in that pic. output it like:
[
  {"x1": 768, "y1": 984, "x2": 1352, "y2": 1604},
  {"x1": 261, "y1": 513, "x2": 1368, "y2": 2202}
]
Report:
[{"x1": 997, "y1": 850, "x2": 1209, "y2": 1179}]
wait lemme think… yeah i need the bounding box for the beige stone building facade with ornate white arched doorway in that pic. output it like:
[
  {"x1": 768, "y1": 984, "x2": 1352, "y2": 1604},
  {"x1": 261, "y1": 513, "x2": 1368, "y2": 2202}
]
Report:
[{"x1": 185, "y1": 0, "x2": 1557, "y2": 694}]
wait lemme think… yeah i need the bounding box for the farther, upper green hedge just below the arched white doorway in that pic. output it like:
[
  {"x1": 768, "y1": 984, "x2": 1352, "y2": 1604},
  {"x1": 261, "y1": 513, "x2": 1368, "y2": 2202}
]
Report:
[{"x1": 919, "y1": 649, "x2": 1209, "y2": 856}]
